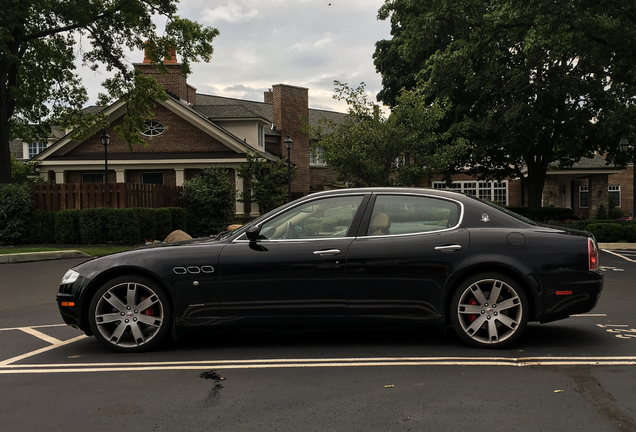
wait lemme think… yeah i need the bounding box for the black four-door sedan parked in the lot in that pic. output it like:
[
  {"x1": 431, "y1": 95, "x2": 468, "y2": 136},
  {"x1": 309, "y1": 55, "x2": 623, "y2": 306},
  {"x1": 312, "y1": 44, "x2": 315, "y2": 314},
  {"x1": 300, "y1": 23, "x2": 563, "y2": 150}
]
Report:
[{"x1": 57, "y1": 188, "x2": 603, "y2": 352}]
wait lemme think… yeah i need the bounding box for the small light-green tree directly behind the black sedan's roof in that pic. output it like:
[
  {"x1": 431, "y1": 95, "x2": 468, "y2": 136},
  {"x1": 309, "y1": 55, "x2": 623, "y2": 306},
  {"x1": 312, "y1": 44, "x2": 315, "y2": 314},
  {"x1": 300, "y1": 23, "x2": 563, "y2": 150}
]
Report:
[{"x1": 310, "y1": 81, "x2": 443, "y2": 186}]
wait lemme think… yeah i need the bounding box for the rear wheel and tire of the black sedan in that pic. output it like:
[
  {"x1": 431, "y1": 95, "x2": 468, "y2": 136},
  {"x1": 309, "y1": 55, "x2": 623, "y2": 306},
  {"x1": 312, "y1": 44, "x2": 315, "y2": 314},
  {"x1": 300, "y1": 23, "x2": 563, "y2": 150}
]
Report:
[{"x1": 450, "y1": 273, "x2": 530, "y2": 348}]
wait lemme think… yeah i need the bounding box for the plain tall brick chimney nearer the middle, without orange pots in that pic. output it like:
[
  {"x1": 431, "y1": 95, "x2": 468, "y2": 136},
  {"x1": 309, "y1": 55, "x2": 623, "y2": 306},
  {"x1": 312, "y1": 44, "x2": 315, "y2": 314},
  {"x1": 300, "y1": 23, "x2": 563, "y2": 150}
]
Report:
[{"x1": 274, "y1": 84, "x2": 310, "y2": 195}]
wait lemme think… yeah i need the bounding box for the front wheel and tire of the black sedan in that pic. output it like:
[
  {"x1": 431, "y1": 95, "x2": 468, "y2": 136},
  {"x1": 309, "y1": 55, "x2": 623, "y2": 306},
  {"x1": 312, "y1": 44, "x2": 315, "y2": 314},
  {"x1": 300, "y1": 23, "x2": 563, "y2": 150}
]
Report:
[{"x1": 88, "y1": 275, "x2": 172, "y2": 352}]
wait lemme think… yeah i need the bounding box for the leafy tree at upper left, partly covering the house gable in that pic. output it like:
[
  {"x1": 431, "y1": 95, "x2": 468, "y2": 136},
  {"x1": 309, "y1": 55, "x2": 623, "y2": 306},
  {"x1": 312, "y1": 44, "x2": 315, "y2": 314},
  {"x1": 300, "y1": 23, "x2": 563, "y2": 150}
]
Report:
[{"x1": 0, "y1": 0, "x2": 218, "y2": 183}]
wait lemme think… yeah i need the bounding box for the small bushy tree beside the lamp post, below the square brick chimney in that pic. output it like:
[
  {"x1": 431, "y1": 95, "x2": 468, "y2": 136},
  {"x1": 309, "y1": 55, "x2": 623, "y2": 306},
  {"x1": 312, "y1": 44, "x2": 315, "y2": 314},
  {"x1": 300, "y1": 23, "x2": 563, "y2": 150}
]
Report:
[{"x1": 238, "y1": 153, "x2": 296, "y2": 214}]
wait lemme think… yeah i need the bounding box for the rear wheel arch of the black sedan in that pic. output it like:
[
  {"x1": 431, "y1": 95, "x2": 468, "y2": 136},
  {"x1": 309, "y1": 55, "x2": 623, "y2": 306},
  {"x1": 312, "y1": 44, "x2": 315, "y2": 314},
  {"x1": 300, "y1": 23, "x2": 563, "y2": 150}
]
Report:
[{"x1": 441, "y1": 262, "x2": 540, "y2": 325}]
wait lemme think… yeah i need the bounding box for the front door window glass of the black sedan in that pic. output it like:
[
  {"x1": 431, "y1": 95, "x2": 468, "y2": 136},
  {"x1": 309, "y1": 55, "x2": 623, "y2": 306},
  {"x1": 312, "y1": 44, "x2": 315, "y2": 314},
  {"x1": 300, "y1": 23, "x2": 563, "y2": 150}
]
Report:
[{"x1": 260, "y1": 195, "x2": 363, "y2": 240}]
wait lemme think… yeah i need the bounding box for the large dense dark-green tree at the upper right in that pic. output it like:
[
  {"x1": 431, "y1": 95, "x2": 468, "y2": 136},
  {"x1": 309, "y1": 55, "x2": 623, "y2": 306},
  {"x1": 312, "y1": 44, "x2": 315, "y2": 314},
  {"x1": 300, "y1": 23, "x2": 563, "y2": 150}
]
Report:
[{"x1": 374, "y1": 0, "x2": 636, "y2": 208}]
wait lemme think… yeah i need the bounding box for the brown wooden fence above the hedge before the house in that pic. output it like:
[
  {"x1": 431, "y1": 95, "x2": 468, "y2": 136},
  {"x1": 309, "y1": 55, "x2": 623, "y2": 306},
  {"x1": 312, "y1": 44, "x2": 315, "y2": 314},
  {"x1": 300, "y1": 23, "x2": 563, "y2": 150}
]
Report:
[{"x1": 31, "y1": 183, "x2": 183, "y2": 211}]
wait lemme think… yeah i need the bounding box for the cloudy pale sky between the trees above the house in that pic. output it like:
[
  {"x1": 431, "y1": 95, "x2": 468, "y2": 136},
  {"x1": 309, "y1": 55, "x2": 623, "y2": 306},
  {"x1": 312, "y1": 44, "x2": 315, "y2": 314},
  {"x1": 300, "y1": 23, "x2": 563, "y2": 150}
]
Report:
[{"x1": 78, "y1": 0, "x2": 391, "y2": 112}]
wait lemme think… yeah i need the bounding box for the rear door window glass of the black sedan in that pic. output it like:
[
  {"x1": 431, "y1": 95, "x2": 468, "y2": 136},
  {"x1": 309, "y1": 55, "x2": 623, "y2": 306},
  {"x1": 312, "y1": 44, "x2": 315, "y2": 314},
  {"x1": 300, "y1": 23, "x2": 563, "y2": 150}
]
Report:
[{"x1": 367, "y1": 195, "x2": 460, "y2": 236}]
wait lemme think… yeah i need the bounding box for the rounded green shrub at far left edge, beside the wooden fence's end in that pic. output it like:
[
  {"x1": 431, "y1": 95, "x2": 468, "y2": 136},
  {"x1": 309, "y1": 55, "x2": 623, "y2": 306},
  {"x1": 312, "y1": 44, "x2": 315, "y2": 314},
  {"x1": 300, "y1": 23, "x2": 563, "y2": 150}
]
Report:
[{"x1": 0, "y1": 184, "x2": 33, "y2": 245}]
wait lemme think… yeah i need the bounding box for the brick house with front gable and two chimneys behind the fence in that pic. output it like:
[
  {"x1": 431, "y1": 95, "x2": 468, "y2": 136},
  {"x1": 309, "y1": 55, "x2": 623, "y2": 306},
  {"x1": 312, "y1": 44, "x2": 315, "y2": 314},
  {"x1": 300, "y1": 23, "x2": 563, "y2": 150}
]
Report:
[{"x1": 31, "y1": 55, "x2": 346, "y2": 213}]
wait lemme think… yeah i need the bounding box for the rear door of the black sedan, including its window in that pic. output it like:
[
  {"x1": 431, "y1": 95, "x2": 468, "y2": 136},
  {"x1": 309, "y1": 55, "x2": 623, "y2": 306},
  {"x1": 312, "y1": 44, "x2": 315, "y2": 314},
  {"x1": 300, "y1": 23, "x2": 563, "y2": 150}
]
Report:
[{"x1": 347, "y1": 193, "x2": 469, "y2": 316}]
